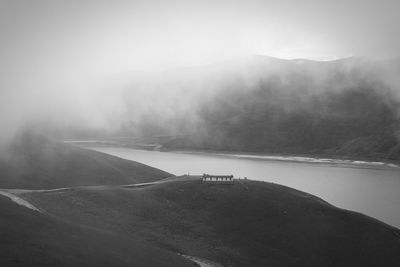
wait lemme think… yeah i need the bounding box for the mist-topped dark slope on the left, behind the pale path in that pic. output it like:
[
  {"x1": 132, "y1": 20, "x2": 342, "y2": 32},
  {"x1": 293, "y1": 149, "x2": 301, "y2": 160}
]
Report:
[{"x1": 0, "y1": 133, "x2": 171, "y2": 189}]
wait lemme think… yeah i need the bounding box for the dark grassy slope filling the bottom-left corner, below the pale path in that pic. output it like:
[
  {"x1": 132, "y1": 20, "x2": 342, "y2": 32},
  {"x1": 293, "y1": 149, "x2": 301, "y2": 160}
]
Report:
[{"x1": 0, "y1": 197, "x2": 192, "y2": 267}]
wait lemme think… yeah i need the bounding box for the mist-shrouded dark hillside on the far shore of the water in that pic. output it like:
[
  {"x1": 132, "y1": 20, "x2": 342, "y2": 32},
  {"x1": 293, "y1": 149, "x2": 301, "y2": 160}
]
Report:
[{"x1": 118, "y1": 56, "x2": 400, "y2": 160}]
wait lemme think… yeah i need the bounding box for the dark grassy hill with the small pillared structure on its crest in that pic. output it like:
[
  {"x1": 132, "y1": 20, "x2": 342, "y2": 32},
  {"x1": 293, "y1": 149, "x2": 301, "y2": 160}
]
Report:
[{"x1": 25, "y1": 181, "x2": 400, "y2": 266}]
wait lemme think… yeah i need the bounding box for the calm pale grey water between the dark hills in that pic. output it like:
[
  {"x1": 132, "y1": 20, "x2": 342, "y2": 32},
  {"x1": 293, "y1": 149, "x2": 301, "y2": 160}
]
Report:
[{"x1": 90, "y1": 146, "x2": 400, "y2": 228}]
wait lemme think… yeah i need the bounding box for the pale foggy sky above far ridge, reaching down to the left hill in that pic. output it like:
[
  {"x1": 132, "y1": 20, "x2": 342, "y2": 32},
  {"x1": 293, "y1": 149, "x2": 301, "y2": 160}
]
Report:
[{"x1": 0, "y1": 0, "x2": 400, "y2": 142}]
